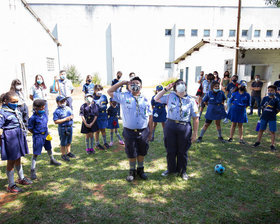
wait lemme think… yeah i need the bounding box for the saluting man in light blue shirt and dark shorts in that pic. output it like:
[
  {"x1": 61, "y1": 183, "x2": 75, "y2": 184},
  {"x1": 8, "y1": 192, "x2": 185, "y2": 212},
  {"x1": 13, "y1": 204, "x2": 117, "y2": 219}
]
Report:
[{"x1": 107, "y1": 77, "x2": 153, "y2": 182}]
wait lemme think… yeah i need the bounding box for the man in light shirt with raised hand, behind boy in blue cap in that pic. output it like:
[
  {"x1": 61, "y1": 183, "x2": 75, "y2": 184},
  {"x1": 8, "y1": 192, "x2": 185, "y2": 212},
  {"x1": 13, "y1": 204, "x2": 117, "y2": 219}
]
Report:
[{"x1": 55, "y1": 70, "x2": 74, "y2": 110}]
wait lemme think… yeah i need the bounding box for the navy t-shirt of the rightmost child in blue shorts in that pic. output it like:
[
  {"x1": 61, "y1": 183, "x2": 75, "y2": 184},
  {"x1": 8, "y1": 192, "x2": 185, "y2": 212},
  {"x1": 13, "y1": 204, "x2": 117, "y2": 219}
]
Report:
[{"x1": 261, "y1": 96, "x2": 280, "y2": 121}]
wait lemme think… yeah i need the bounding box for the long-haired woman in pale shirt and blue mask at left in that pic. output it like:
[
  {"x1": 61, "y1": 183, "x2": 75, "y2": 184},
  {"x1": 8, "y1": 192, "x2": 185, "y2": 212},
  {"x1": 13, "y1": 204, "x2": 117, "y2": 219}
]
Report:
[{"x1": 29, "y1": 75, "x2": 48, "y2": 114}]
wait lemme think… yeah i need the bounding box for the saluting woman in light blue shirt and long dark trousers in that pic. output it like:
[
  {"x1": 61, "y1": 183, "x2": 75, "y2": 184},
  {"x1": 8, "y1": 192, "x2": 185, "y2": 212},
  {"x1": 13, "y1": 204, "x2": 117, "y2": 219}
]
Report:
[{"x1": 155, "y1": 79, "x2": 199, "y2": 180}]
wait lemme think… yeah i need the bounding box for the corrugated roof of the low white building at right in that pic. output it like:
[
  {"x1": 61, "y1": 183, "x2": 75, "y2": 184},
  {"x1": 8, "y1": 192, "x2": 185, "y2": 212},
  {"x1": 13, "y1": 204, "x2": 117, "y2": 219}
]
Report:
[{"x1": 172, "y1": 39, "x2": 280, "y2": 64}]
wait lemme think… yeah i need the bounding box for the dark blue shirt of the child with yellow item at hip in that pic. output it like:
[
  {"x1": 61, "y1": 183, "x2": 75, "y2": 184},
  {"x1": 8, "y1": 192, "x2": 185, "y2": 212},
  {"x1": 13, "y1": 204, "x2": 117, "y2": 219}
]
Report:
[{"x1": 28, "y1": 112, "x2": 48, "y2": 134}]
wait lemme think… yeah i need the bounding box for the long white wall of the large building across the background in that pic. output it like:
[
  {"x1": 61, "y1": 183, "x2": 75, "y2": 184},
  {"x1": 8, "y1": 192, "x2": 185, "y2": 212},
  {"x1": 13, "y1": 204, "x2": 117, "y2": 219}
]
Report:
[{"x1": 24, "y1": 0, "x2": 280, "y2": 86}]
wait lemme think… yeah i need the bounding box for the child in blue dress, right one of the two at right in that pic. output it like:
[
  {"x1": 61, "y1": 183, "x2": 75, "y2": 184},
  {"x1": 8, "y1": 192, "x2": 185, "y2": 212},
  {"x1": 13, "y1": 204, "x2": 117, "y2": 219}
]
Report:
[{"x1": 227, "y1": 80, "x2": 251, "y2": 144}]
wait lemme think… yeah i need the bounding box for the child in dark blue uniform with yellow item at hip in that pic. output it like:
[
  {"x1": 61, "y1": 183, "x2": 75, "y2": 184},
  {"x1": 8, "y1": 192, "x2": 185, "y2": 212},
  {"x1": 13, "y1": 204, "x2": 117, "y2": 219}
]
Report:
[{"x1": 28, "y1": 99, "x2": 61, "y2": 180}]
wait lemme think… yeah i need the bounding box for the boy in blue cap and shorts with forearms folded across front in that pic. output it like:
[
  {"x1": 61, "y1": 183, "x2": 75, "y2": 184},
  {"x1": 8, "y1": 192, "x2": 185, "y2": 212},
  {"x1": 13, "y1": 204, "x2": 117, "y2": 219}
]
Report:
[{"x1": 53, "y1": 96, "x2": 76, "y2": 162}]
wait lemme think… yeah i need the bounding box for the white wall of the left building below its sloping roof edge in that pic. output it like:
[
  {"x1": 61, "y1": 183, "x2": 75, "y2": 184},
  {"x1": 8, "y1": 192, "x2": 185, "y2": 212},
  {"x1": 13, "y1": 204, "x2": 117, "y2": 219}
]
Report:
[{"x1": 0, "y1": 0, "x2": 58, "y2": 93}]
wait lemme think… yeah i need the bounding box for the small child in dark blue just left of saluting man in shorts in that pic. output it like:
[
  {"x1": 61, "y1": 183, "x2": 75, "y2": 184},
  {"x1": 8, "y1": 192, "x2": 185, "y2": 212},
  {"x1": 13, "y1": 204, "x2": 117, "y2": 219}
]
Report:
[{"x1": 107, "y1": 98, "x2": 124, "y2": 146}]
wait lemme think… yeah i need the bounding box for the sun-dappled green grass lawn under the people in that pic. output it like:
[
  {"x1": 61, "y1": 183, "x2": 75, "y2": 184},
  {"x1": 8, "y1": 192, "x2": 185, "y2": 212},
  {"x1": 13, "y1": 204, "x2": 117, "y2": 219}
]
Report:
[{"x1": 0, "y1": 115, "x2": 280, "y2": 224}]
